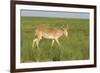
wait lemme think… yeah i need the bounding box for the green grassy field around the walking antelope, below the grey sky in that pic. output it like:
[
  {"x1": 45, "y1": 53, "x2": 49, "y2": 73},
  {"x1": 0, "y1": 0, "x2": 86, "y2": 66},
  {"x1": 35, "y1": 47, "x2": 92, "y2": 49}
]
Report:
[{"x1": 21, "y1": 17, "x2": 89, "y2": 62}]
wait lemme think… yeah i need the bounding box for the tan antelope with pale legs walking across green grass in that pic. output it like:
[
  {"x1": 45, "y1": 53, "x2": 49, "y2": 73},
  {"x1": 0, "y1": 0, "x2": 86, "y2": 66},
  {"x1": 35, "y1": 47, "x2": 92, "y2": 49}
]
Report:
[{"x1": 32, "y1": 27, "x2": 68, "y2": 48}]
